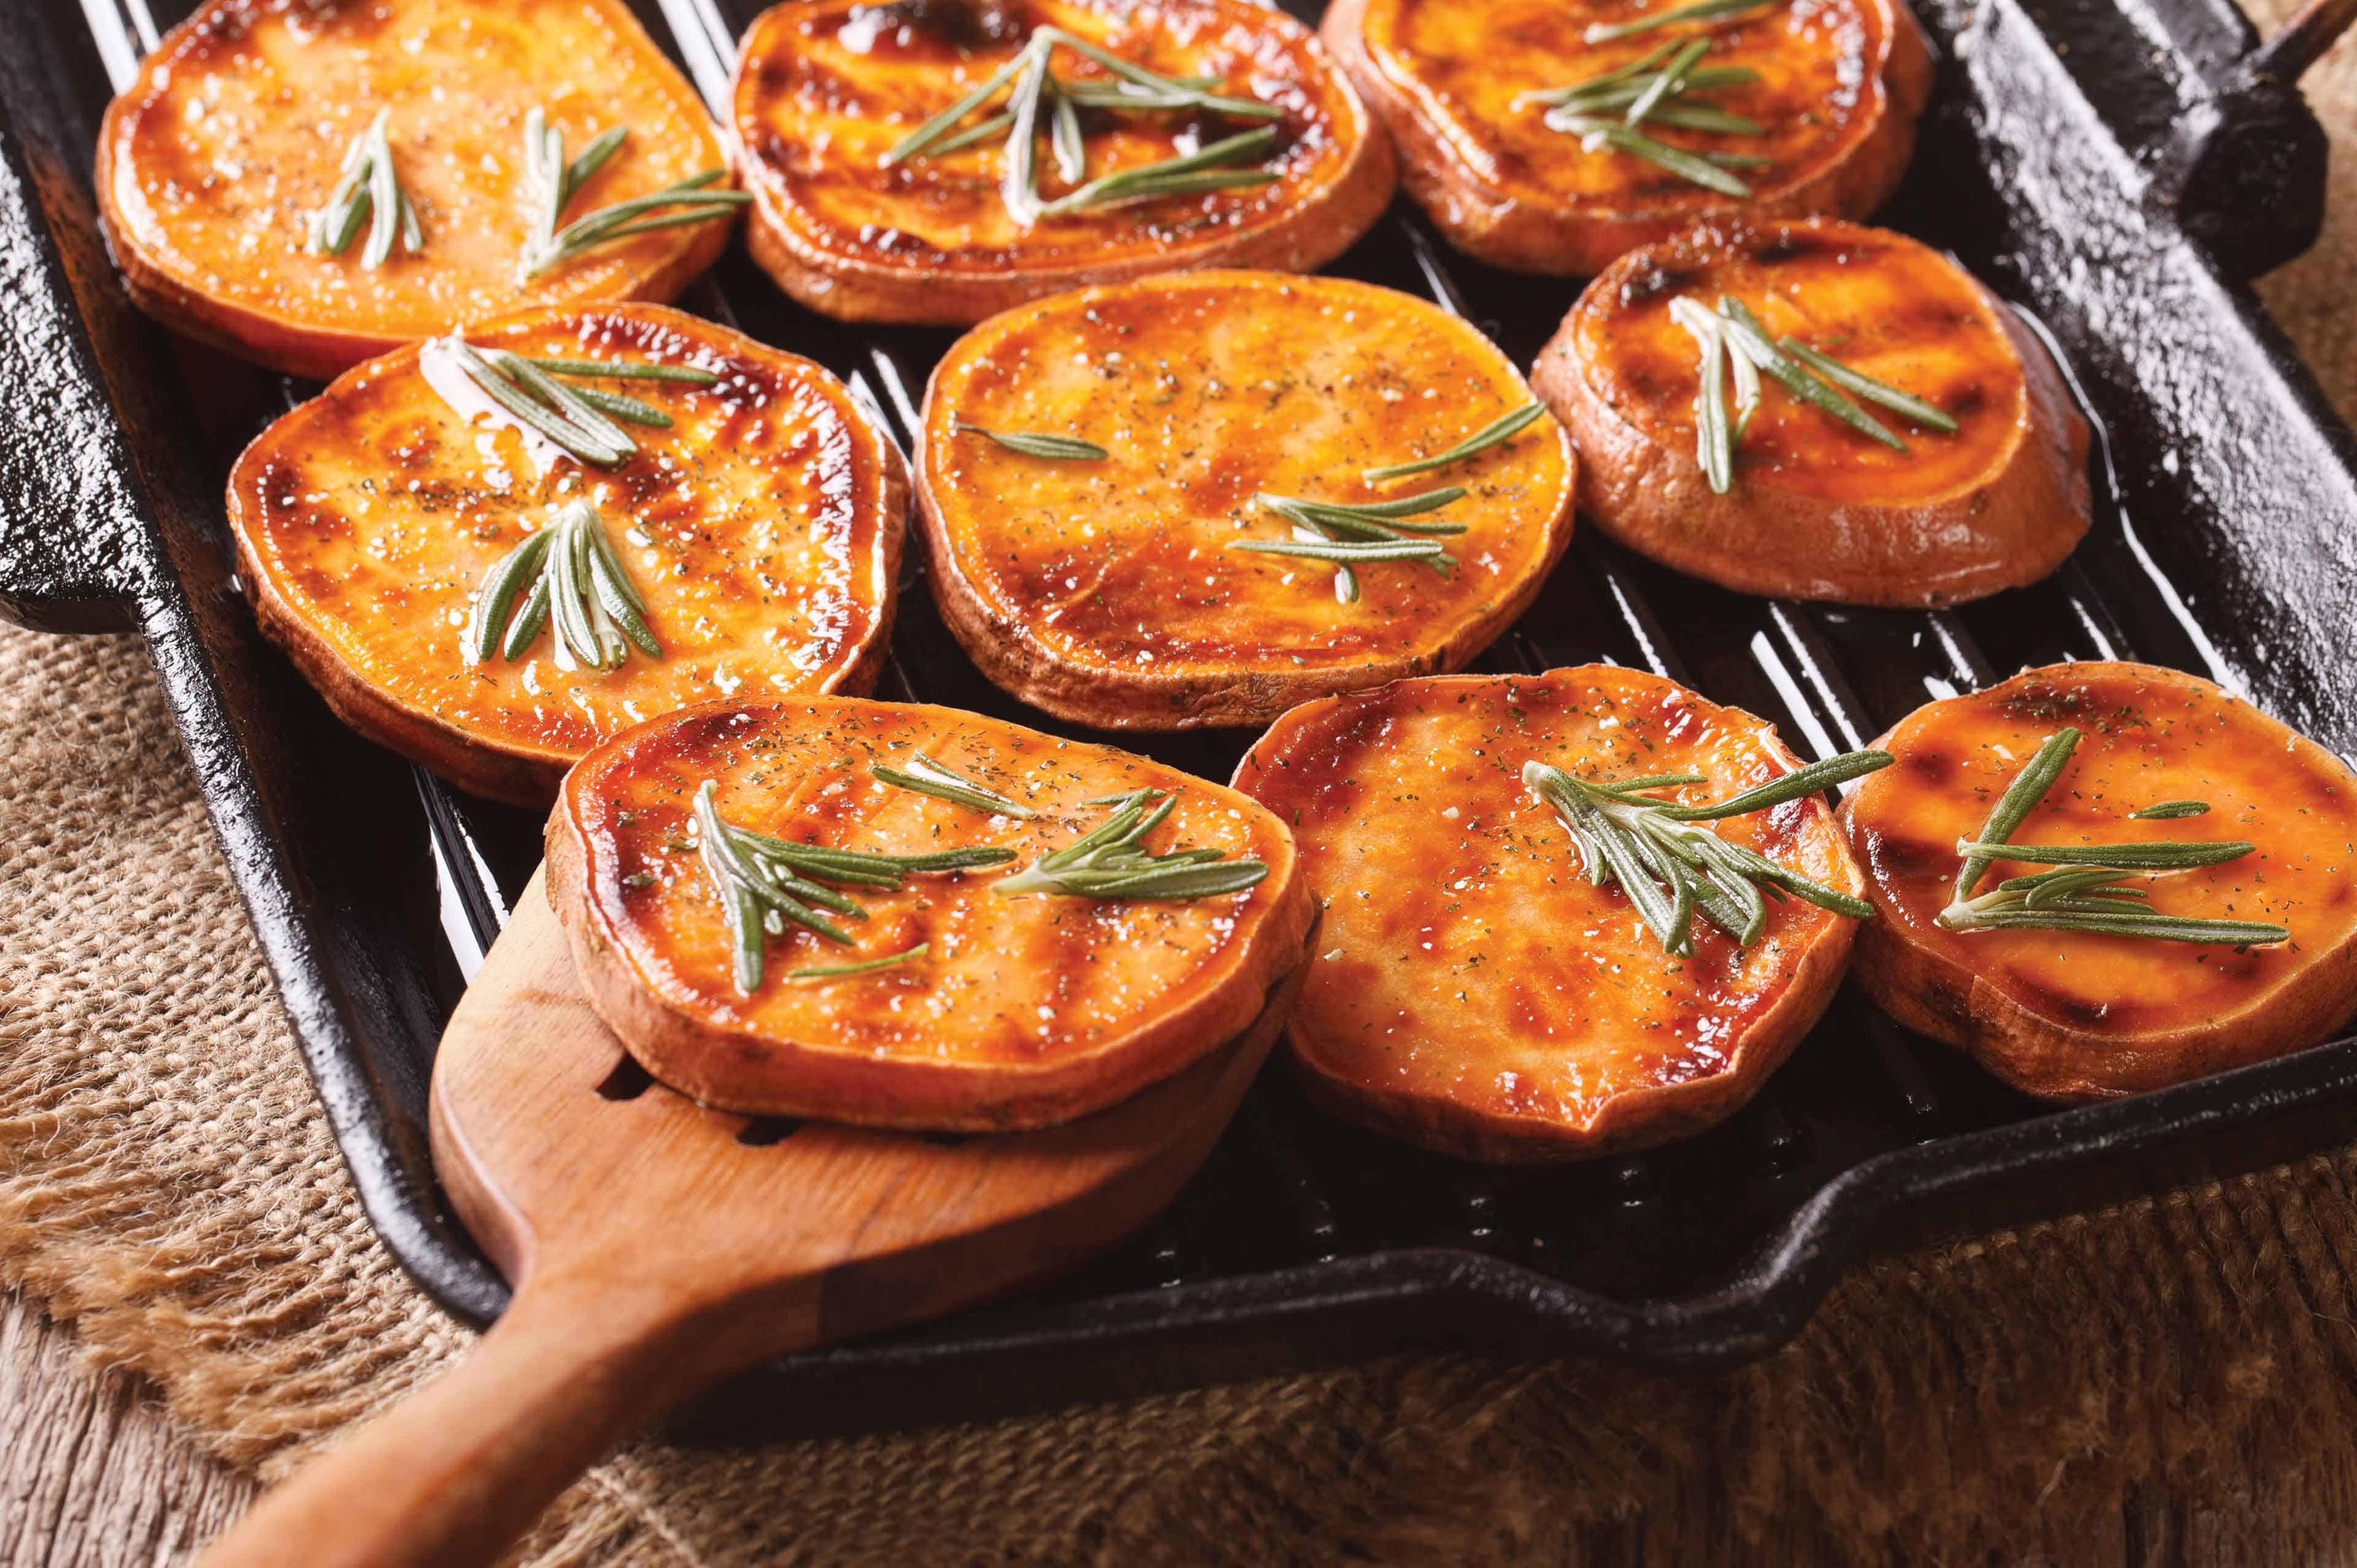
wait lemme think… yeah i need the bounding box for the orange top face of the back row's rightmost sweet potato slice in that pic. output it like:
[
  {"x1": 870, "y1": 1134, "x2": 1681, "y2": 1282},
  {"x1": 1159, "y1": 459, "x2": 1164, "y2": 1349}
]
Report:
[{"x1": 1363, "y1": 0, "x2": 1891, "y2": 217}]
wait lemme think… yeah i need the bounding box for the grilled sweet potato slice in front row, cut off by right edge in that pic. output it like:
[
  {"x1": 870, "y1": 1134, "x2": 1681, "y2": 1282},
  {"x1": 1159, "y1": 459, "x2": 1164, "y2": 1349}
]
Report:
[{"x1": 1841, "y1": 663, "x2": 2357, "y2": 1101}]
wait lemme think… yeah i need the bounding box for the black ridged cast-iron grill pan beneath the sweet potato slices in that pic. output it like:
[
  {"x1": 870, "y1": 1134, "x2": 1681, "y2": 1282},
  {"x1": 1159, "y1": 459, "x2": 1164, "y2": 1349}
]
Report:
[{"x1": 0, "y1": 0, "x2": 2357, "y2": 1436}]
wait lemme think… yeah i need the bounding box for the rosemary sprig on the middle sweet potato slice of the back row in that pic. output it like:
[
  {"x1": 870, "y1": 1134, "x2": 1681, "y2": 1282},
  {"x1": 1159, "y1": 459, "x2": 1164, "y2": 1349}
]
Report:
[{"x1": 884, "y1": 28, "x2": 1285, "y2": 229}]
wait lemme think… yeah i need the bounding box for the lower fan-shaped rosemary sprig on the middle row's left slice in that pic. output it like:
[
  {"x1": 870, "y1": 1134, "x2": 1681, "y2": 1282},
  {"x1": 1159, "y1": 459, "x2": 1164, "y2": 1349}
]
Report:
[{"x1": 466, "y1": 500, "x2": 662, "y2": 670}]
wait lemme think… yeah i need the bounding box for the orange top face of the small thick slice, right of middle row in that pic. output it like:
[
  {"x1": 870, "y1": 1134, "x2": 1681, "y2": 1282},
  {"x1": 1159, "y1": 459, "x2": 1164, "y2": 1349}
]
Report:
[{"x1": 1568, "y1": 224, "x2": 2032, "y2": 504}]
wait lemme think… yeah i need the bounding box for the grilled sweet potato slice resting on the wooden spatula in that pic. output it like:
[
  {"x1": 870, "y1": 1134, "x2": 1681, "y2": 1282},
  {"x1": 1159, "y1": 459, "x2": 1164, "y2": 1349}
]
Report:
[{"x1": 549, "y1": 698, "x2": 1315, "y2": 1132}]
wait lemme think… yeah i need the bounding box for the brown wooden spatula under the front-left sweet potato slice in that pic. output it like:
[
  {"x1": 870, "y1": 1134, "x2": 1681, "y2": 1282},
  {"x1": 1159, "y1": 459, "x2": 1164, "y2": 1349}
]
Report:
[{"x1": 203, "y1": 875, "x2": 1299, "y2": 1568}]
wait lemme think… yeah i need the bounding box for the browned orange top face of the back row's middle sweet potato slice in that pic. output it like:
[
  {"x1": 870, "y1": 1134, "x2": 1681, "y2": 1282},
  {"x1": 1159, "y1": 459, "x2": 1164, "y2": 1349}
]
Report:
[{"x1": 735, "y1": 0, "x2": 1388, "y2": 301}]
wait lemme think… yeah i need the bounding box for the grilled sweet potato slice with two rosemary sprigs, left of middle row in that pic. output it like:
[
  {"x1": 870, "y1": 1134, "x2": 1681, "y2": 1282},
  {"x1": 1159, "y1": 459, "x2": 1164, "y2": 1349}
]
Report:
[{"x1": 228, "y1": 304, "x2": 907, "y2": 806}]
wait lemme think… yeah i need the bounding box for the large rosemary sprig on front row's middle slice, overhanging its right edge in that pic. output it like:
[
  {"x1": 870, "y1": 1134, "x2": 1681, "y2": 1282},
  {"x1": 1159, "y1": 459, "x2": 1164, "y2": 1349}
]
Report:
[{"x1": 1523, "y1": 752, "x2": 1893, "y2": 957}]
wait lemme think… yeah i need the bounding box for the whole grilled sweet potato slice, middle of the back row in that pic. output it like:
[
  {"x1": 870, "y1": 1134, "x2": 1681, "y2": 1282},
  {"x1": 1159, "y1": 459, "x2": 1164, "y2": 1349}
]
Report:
[{"x1": 730, "y1": 0, "x2": 1395, "y2": 325}]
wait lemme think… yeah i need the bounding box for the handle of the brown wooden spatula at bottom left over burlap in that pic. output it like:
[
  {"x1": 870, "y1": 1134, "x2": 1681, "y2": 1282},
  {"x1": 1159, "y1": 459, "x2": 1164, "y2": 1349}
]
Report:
[{"x1": 198, "y1": 1283, "x2": 792, "y2": 1568}]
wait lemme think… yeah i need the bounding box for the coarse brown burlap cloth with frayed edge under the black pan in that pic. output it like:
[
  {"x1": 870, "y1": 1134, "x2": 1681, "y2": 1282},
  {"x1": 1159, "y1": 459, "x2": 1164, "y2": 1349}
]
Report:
[{"x1": 0, "y1": 12, "x2": 2357, "y2": 1566}]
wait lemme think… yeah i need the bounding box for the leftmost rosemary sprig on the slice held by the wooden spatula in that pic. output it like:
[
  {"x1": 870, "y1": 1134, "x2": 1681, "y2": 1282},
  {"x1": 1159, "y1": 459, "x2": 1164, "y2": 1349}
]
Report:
[{"x1": 695, "y1": 778, "x2": 1016, "y2": 995}]
